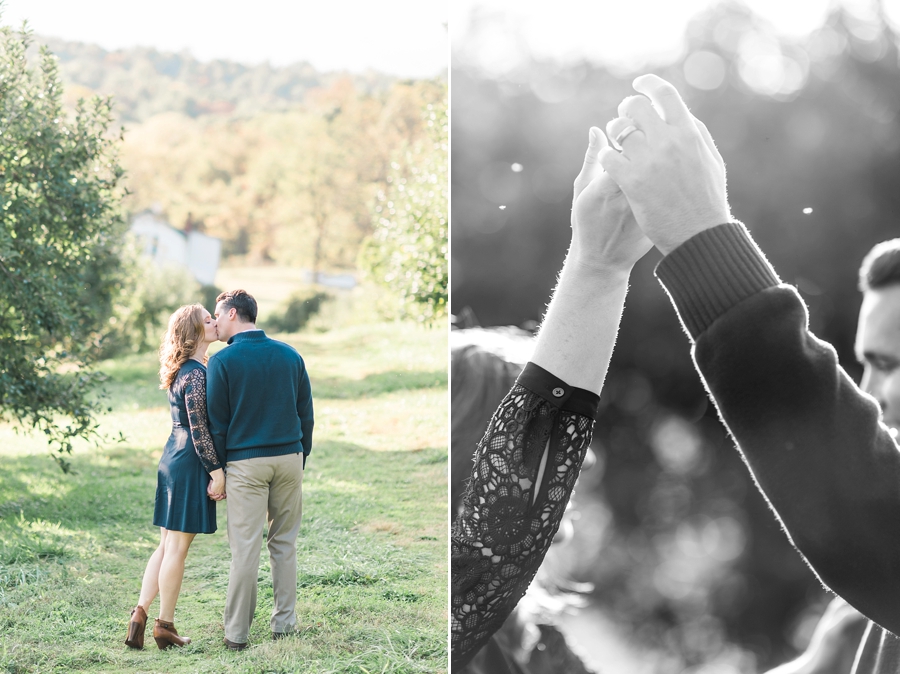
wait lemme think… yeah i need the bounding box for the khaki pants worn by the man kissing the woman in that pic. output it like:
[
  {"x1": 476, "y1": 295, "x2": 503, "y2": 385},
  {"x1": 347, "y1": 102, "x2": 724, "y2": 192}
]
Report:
[{"x1": 225, "y1": 454, "x2": 303, "y2": 644}]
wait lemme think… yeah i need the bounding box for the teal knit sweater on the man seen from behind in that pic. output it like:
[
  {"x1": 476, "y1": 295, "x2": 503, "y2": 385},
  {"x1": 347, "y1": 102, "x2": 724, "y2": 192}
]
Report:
[{"x1": 206, "y1": 330, "x2": 313, "y2": 465}]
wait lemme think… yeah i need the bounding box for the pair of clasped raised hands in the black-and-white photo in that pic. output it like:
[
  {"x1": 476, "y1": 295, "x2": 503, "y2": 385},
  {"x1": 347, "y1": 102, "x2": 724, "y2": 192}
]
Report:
[{"x1": 569, "y1": 75, "x2": 731, "y2": 276}]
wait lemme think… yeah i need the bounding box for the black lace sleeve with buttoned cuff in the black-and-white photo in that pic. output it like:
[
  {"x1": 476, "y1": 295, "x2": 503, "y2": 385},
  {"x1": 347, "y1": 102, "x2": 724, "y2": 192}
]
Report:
[{"x1": 450, "y1": 363, "x2": 599, "y2": 669}]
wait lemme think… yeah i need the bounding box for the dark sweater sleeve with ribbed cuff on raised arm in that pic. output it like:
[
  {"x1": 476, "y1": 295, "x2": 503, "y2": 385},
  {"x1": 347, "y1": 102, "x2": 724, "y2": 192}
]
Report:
[{"x1": 657, "y1": 223, "x2": 900, "y2": 634}]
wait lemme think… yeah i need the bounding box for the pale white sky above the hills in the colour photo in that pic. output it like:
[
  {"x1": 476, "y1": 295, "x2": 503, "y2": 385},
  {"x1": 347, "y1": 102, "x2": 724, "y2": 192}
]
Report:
[{"x1": 2, "y1": 0, "x2": 449, "y2": 78}]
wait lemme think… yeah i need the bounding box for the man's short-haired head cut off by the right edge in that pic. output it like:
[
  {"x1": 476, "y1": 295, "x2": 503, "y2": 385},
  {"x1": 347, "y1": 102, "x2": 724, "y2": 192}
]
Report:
[{"x1": 856, "y1": 239, "x2": 900, "y2": 429}]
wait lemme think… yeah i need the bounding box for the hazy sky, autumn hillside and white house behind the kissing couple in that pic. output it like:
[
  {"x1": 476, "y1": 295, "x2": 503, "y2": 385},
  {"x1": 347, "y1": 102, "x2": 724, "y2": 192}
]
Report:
[{"x1": 2, "y1": 0, "x2": 448, "y2": 346}]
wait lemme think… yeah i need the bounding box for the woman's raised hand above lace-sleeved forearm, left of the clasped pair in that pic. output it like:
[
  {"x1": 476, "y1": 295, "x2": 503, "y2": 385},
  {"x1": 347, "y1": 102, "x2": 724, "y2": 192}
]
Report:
[{"x1": 569, "y1": 127, "x2": 653, "y2": 275}]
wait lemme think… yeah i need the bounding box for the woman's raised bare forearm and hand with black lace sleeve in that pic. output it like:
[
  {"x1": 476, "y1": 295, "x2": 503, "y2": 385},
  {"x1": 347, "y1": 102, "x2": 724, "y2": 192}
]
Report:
[{"x1": 451, "y1": 129, "x2": 650, "y2": 669}]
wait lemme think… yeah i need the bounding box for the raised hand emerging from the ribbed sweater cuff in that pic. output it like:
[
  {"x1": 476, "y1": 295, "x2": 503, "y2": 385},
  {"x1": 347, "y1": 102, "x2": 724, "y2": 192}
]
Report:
[{"x1": 598, "y1": 75, "x2": 731, "y2": 253}]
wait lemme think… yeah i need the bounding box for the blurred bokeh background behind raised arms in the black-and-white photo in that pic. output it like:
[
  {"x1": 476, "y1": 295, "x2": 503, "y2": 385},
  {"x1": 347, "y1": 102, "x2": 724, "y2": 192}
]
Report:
[{"x1": 450, "y1": 0, "x2": 900, "y2": 673}]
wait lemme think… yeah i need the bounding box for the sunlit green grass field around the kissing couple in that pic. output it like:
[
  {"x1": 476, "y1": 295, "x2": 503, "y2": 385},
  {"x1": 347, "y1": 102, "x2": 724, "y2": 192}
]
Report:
[{"x1": 0, "y1": 324, "x2": 447, "y2": 674}]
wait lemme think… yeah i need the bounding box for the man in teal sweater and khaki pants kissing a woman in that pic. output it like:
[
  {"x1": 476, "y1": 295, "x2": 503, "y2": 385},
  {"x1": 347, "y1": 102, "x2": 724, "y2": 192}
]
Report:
[{"x1": 206, "y1": 290, "x2": 313, "y2": 650}]
